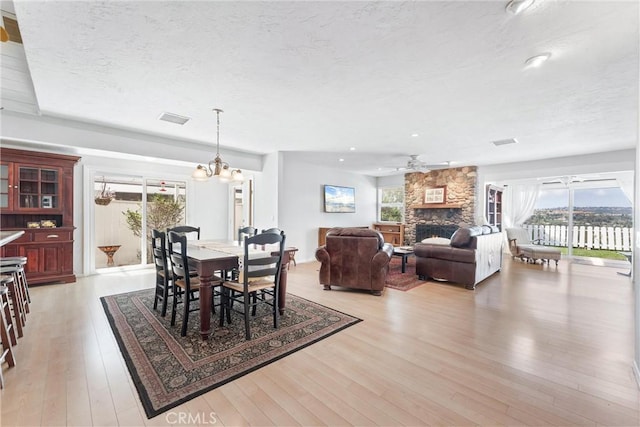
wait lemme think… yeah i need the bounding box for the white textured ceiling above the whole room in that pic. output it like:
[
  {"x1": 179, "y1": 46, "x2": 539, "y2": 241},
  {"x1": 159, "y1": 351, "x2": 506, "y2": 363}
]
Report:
[{"x1": 5, "y1": 0, "x2": 639, "y2": 175}]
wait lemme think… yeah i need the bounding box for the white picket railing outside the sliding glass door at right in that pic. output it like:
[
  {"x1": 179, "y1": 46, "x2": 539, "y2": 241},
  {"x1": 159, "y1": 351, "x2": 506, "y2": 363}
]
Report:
[{"x1": 524, "y1": 224, "x2": 633, "y2": 251}]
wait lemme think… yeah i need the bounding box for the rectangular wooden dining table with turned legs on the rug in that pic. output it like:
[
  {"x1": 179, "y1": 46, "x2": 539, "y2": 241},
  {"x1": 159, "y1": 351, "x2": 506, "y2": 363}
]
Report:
[{"x1": 187, "y1": 240, "x2": 290, "y2": 341}]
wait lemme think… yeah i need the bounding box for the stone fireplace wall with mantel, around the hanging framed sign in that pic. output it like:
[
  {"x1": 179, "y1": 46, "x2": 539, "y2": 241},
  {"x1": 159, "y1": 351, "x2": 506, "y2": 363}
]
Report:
[{"x1": 404, "y1": 166, "x2": 477, "y2": 244}]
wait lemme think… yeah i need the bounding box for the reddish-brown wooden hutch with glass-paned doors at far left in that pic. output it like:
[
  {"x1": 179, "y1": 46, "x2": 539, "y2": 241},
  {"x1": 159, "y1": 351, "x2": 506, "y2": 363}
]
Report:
[{"x1": 0, "y1": 148, "x2": 79, "y2": 284}]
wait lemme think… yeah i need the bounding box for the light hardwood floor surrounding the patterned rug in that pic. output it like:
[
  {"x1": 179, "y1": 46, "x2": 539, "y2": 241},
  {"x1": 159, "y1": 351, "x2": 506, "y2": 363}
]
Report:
[{"x1": 0, "y1": 257, "x2": 640, "y2": 426}]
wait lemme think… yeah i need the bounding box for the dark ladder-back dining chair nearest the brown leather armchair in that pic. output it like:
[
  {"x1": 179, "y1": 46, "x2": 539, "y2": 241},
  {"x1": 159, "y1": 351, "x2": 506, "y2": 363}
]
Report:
[{"x1": 220, "y1": 232, "x2": 285, "y2": 340}]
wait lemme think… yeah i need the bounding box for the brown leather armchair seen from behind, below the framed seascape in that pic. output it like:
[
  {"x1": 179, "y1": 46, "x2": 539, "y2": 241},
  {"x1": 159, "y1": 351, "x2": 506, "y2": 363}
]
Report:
[{"x1": 316, "y1": 228, "x2": 393, "y2": 295}]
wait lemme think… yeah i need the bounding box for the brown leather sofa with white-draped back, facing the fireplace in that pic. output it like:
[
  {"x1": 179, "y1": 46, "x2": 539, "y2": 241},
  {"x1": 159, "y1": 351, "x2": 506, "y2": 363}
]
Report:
[{"x1": 414, "y1": 225, "x2": 503, "y2": 289}]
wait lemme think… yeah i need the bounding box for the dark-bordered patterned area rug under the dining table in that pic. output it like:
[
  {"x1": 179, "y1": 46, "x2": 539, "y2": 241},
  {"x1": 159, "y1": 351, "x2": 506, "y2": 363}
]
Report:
[{"x1": 100, "y1": 289, "x2": 361, "y2": 418}]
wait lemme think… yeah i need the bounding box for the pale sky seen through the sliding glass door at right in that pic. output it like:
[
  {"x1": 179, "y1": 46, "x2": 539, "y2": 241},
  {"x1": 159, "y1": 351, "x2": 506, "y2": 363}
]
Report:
[{"x1": 536, "y1": 188, "x2": 631, "y2": 209}]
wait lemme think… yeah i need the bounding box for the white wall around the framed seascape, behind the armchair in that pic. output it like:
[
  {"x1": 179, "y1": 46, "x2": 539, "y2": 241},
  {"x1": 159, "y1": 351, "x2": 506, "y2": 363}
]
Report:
[{"x1": 278, "y1": 153, "x2": 377, "y2": 262}]
